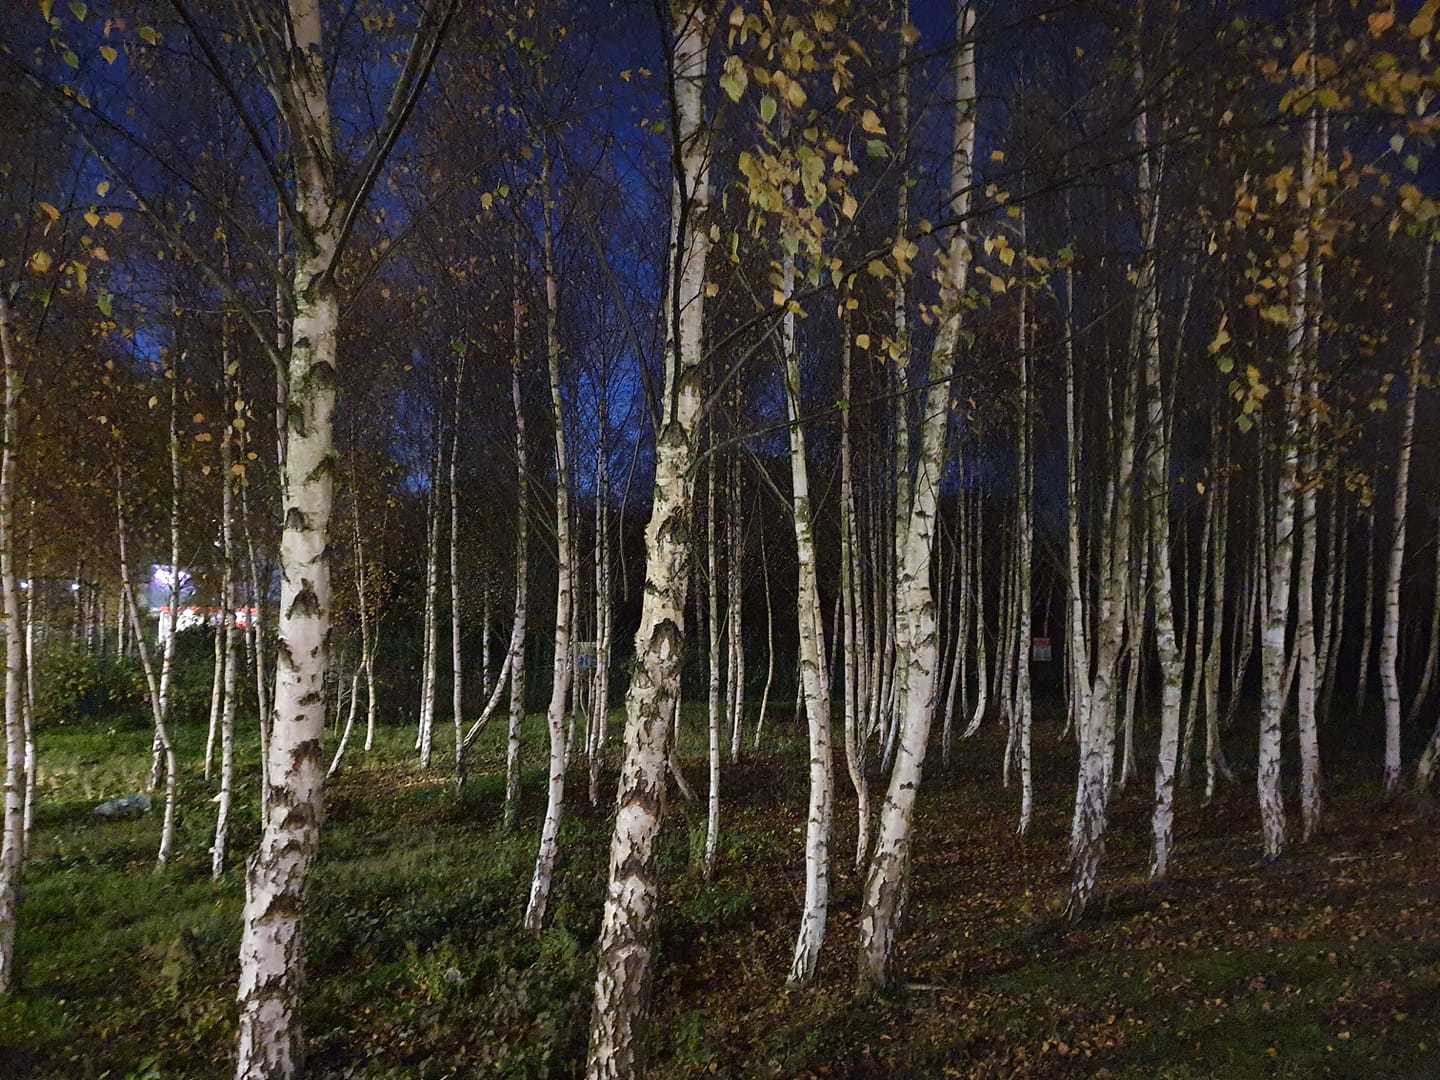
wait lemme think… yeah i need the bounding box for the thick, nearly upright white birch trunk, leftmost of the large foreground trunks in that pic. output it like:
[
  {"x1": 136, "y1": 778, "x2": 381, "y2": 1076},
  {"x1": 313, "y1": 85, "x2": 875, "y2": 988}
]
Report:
[{"x1": 236, "y1": 0, "x2": 340, "y2": 1077}]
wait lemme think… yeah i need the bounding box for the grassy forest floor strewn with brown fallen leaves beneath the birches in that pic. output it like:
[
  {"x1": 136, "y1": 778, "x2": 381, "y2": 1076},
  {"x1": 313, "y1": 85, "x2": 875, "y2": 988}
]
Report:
[{"x1": 0, "y1": 696, "x2": 1440, "y2": 1080}]
